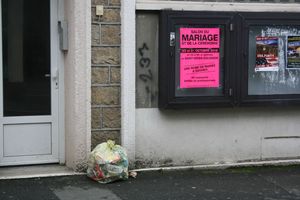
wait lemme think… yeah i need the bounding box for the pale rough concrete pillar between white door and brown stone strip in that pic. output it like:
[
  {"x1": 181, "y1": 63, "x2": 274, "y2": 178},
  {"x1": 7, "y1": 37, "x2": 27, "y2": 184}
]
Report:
[{"x1": 64, "y1": 0, "x2": 91, "y2": 171}]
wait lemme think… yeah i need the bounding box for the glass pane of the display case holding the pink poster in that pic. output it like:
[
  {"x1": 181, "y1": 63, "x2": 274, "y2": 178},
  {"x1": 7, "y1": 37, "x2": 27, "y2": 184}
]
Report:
[{"x1": 175, "y1": 25, "x2": 225, "y2": 97}]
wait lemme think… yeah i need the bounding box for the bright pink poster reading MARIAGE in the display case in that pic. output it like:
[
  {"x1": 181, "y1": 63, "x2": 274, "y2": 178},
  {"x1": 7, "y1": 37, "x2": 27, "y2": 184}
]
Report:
[{"x1": 180, "y1": 28, "x2": 220, "y2": 88}]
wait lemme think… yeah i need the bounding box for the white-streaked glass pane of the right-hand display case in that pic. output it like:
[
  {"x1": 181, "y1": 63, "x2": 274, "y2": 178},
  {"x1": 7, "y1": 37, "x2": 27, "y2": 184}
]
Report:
[{"x1": 248, "y1": 26, "x2": 300, "y2": 95}]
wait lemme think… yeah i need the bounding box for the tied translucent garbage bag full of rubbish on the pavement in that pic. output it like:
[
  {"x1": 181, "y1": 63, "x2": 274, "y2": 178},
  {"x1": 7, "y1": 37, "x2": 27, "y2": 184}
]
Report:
[{"x1": 87, "y1": 140, "x2": 128, "y2": 183}]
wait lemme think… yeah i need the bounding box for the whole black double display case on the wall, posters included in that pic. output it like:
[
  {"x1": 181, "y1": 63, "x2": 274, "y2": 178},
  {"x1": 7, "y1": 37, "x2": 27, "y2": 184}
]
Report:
[{"x1": 159, "y1": 11, "x2": 300, "y2": 108}]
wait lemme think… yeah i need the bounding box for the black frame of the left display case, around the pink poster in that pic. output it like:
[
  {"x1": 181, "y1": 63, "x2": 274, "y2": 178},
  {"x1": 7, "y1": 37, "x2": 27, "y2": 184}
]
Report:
[{"x1": 159, "y1": 11, "x2": 235, "y2": 108}]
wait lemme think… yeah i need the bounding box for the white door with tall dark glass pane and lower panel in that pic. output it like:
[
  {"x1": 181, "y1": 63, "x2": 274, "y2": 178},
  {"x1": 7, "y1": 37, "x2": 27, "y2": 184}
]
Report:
[{"x1": 0, "y1": 0, "x2": 59, "y2": 166}]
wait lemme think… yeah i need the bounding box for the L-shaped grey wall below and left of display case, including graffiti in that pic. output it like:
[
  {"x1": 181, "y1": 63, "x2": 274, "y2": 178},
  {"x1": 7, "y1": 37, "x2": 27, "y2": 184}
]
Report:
[{"x1": 135, "y1": 13, "x2": 300, "y2": 168}]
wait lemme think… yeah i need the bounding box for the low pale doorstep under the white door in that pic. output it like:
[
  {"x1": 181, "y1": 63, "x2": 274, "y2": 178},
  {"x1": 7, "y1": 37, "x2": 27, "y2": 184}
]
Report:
[{"x1": 0, "y1": 164, "x2": 85, "y2": 180}]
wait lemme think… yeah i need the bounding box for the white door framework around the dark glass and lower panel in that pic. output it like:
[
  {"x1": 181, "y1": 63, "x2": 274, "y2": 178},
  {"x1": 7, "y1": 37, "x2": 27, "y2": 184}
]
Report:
[{"x1": 0, "y1": 0, "x2": 65, "y2": 166}]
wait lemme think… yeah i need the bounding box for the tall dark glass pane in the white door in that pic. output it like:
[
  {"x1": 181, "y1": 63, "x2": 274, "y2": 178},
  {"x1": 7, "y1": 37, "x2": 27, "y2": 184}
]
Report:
[{"x1": 2, "y1": 0, "x2": 51, "y2": 116}]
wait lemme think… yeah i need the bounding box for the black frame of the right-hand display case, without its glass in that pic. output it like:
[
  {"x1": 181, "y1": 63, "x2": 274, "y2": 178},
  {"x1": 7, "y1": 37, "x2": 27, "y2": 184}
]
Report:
[{"x1": 237, "y1": 13, "x2": 300, "y2": 106}]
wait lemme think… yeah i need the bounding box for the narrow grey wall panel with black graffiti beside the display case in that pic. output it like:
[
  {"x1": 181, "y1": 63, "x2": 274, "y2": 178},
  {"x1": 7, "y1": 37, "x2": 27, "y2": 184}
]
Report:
[{"x1": 136, "y1": 12, "x2": 159, "y2": 108}]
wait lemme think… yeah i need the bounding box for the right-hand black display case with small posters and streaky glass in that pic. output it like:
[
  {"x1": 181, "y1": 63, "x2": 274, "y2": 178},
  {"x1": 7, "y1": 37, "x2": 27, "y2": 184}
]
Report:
[{"x1": 239, "y1": 13, "x2": 300, "y2": 105}]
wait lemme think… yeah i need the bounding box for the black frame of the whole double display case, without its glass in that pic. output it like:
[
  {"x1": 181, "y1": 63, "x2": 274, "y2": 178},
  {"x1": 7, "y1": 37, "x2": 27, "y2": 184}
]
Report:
[{"x1": 159, "y1": 11, "x2": 300, "y2": 108}]
